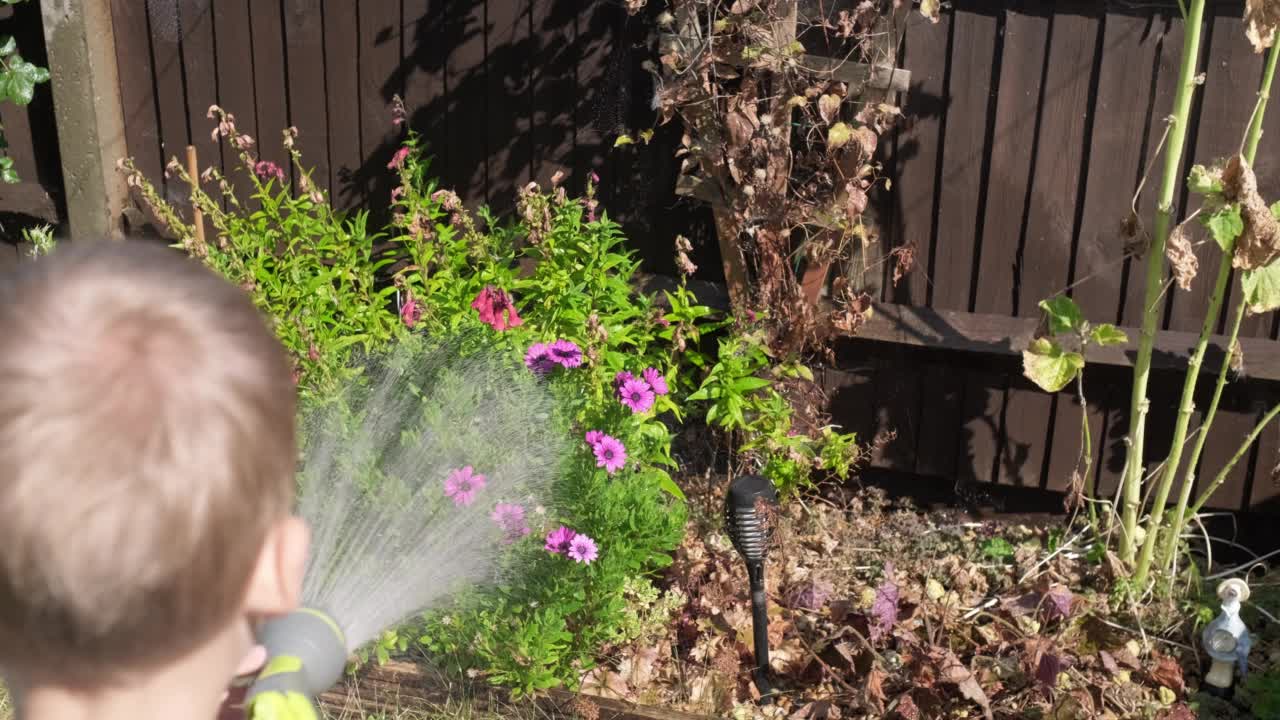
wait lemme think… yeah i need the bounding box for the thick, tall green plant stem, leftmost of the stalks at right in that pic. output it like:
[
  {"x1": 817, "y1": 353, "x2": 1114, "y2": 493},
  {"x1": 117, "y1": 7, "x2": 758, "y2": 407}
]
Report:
[{"x1": 1120, "y1": 0, "x2": 1204, "y2": 562}]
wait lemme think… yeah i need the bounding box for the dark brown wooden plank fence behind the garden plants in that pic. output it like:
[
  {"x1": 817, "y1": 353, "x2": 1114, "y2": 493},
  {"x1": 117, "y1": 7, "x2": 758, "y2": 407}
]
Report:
[{"x1": 30, "y1": 0, "x2": 1280, "y2": 514}]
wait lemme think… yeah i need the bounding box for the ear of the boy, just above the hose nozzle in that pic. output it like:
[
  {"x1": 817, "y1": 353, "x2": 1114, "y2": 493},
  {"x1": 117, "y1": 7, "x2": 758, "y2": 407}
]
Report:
[{"x1": 244, "y1": 516, "x2": 311, "y2": 616}]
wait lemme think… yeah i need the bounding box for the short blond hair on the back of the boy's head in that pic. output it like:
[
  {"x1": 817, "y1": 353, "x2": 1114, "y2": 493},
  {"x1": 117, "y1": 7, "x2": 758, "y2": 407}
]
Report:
[{"x1": 0, "y1": 241, "x2": 296, "y2": 683}]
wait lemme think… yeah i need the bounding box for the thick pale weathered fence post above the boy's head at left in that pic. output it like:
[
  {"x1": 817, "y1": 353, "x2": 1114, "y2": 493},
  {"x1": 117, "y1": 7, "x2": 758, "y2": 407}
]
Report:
[{"x1": 40, "y1": 0, "x2": 128, "y2": 240}]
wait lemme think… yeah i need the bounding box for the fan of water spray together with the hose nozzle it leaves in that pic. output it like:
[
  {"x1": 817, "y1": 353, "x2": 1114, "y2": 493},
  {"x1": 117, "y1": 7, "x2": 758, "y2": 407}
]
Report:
[{"x1": 246, "y1": 338, "x2": 568, "y2": 720}]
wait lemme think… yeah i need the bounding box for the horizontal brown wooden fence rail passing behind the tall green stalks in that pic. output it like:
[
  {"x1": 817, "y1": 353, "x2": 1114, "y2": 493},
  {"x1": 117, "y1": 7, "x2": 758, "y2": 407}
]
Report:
[{"x1": 854, "y1": 302, "x2": 1280, "y2": 380}]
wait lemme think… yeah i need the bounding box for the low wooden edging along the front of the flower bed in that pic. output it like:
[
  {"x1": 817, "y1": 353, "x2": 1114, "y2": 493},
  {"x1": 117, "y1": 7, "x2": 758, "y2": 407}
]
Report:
[{"x1": 319, "y1": 660, "x2": 710, "y2": 720}]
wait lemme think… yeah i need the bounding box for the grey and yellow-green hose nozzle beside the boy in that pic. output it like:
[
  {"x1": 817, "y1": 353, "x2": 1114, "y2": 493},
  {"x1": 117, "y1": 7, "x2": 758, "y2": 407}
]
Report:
[{"x1": 244, "y1": 607, "x2": 347, "y2": 720}]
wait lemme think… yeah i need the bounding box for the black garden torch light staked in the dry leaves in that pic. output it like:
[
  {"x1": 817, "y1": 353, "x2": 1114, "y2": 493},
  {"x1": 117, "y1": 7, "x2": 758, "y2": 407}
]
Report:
[{"x1": 724, "y1": 475, "x2": 778, "y2": 705}]
